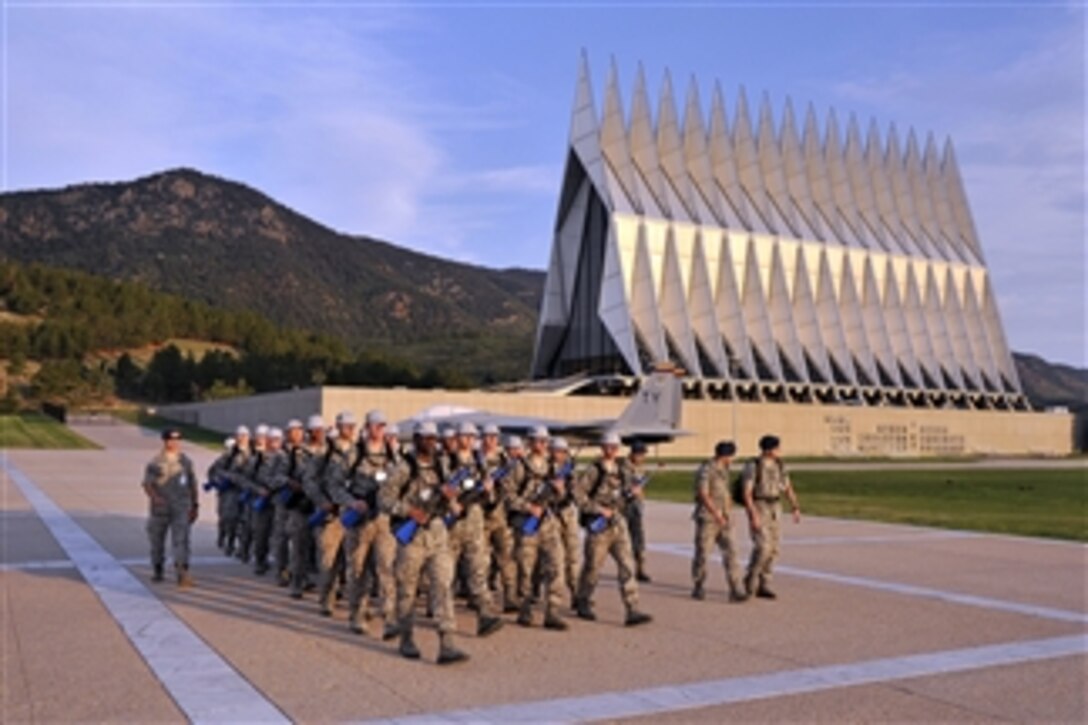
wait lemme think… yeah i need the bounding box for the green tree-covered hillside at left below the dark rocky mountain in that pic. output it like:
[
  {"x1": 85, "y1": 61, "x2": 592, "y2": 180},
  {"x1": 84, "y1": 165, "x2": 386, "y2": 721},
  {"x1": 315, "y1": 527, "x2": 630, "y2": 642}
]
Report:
[{"x1": 0, "y1": 261, "x2": 468, "y2": 409}]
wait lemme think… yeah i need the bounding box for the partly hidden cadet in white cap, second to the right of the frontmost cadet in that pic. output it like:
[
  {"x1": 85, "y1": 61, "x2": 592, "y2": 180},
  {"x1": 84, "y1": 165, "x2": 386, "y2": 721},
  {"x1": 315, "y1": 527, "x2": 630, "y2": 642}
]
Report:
[{"x1": 480, "y1": 423, "x2": 521, "y2": 613}]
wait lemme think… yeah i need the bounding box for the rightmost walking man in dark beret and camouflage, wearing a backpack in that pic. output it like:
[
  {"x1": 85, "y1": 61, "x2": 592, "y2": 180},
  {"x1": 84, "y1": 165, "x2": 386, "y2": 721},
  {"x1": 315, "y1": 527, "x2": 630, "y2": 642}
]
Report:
[{"x1": 741, "y1": 435, "x2": 801, "y2": 599}]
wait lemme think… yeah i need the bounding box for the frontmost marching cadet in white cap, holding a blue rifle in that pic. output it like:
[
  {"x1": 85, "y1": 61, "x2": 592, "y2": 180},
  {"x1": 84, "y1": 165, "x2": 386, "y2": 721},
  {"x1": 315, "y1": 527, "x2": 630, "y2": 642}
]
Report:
[{"x1": 384, "y1": 421, "x2": 468, "y2": 664}]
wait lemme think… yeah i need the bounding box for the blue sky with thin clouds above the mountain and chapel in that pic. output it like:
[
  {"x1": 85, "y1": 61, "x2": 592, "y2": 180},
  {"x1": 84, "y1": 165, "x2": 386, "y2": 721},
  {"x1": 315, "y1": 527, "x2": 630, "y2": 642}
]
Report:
[{"x1": 2, "y1": 0, "x2": 1088, "y2": 365}]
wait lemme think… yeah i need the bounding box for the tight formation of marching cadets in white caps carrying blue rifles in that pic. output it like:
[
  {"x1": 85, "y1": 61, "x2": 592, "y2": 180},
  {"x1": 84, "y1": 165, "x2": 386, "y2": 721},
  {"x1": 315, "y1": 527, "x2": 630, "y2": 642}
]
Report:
[{"x1": 206, "y1": 410, "x2": 651, "y2": 664}]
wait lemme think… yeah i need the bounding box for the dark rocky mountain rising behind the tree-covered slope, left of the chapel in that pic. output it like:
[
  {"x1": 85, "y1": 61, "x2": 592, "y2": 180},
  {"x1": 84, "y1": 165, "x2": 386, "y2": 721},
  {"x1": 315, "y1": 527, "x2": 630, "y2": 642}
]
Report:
[{"x1": 0, "y1": 169, "x2": 544, "y2": 379}]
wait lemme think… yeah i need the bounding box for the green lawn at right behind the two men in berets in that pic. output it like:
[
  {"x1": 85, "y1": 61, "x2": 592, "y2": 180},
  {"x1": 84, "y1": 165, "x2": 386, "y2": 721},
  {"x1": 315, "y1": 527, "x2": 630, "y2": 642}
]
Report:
[{"x1": 646, "y1": 469, "x2": 1088, "y2": 541}]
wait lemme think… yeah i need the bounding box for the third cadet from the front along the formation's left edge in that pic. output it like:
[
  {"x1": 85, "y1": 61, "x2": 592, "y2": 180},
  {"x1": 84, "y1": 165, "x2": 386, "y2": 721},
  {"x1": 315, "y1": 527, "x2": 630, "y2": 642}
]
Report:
[{"x1": 305, "y1": 410, "x2": 356, "y2": 617}]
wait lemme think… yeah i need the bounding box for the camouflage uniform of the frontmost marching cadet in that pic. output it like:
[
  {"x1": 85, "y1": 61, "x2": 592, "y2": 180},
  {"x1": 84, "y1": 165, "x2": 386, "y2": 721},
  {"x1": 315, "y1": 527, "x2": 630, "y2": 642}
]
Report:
[{"x1": 382, "y1": 454, "x2": 457, "y2": 658}]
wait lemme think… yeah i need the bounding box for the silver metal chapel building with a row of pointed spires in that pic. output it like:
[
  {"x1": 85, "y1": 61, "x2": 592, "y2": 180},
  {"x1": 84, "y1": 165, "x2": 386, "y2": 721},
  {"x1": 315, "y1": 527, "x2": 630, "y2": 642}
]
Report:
[{"x1": 533, "y1": 56, "x2": 1022, "y2": 409}]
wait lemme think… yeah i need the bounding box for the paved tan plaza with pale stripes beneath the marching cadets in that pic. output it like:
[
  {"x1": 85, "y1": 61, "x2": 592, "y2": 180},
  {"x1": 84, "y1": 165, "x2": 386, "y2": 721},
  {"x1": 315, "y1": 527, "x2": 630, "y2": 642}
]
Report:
[{"x1": 0, "y1": 426, "x2": 1088, "y2": 723}]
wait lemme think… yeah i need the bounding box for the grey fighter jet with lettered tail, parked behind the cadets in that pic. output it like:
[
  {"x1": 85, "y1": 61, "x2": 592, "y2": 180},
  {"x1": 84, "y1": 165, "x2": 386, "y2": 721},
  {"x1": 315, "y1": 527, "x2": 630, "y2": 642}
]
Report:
[{"x1": 397, "y1": 369, "x2": 691, "y2": 444}]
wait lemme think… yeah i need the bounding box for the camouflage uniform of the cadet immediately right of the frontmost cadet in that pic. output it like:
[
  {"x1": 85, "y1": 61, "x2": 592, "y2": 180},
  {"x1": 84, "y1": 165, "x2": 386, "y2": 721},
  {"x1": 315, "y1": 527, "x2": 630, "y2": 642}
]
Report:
[{"x1": 446, "y1": 451, "x2": 494, "y2": 623}]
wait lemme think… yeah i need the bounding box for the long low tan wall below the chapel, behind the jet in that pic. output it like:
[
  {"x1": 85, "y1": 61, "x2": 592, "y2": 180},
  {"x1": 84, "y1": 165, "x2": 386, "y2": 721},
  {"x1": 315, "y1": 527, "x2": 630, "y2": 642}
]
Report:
[{"x1": 160, "y1": 388, "x2": 1074, "y2": 457}]
